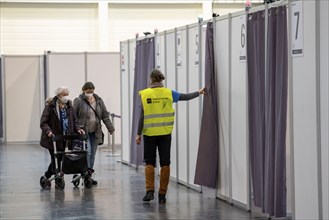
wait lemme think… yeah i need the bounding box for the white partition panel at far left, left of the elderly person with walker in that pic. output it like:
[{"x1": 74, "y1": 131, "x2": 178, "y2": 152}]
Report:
[{"x1": 3, "y1": 56, "x2": 44, "y2": 142}]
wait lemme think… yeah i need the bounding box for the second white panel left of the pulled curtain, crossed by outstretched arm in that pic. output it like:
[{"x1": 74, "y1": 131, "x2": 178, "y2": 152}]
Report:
[{"x1": 176, "y1": 29, "x2": 189, "y2": 184}]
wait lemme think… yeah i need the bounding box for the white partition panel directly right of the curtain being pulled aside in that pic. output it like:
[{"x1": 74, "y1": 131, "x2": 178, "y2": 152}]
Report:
[{"x1": 214, "y1": 19, "x2": 231, "y2": 198}]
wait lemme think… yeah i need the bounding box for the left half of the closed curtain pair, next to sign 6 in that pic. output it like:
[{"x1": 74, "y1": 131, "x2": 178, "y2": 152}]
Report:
[{"x1": 247, "y1": 11, "x2": 265, "y2": 210}]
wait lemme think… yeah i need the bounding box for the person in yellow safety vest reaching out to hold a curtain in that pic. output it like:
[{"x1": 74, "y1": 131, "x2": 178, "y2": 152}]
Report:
[{"x1": 136, "y1": 69, "x2": 206, "y2": 203}]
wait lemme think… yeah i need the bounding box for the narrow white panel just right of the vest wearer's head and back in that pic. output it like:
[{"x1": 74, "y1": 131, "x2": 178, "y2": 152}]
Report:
[{"x1": 165, "y1": 32, "x2": 177, "y2": 178}]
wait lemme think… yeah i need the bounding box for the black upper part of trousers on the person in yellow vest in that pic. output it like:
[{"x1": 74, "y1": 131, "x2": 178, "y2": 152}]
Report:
[{"x1": 143, "y1": 134, "x2": 171, "y2": 166}]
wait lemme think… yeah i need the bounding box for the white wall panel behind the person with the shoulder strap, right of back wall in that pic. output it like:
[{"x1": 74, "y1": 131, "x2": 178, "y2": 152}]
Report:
[{"x1": 86, "y1": 53, "x2": 121, "y2": 146}]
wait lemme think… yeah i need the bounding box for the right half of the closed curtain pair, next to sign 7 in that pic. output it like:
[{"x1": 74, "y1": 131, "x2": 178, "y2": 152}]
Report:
[{"x1": 264, "y1": 7, "x2": 288, "y2": 217}]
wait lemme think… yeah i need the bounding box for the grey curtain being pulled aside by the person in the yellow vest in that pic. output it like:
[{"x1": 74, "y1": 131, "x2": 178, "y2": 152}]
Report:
[{"x1": 194, "y1": 22, "x2": 219, "y2": 188}]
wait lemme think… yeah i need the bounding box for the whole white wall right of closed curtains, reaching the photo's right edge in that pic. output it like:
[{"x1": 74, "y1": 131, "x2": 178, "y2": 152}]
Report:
[{"x1": 291, "y1": 1, "x2": 329, "y2": 219}]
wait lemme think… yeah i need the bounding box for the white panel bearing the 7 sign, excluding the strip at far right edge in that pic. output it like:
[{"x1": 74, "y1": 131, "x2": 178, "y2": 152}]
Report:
[{"x1": 292, "y1": 1, "x2": 319, "y2": 219}]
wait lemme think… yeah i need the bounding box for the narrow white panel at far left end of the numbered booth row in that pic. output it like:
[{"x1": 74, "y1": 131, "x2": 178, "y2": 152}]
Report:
[{"x1": 120, "y1": 41, "x2": 131, "y2": 163}]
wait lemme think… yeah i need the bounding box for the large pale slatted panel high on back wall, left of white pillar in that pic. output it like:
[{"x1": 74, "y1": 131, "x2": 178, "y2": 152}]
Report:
[{"x1": 0, "y1": 2, "x2": 97, "y2": 54}]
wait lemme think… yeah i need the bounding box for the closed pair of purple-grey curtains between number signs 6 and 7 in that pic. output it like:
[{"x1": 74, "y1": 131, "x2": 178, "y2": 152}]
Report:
[{"x1": 247, "y1": 7, "x2": 288, "y2": 217}]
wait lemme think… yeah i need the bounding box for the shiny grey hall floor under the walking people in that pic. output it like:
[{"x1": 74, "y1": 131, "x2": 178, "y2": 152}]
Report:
[{"x1": 0, "y1": 144, "x2": 288, "y2": 219}]
